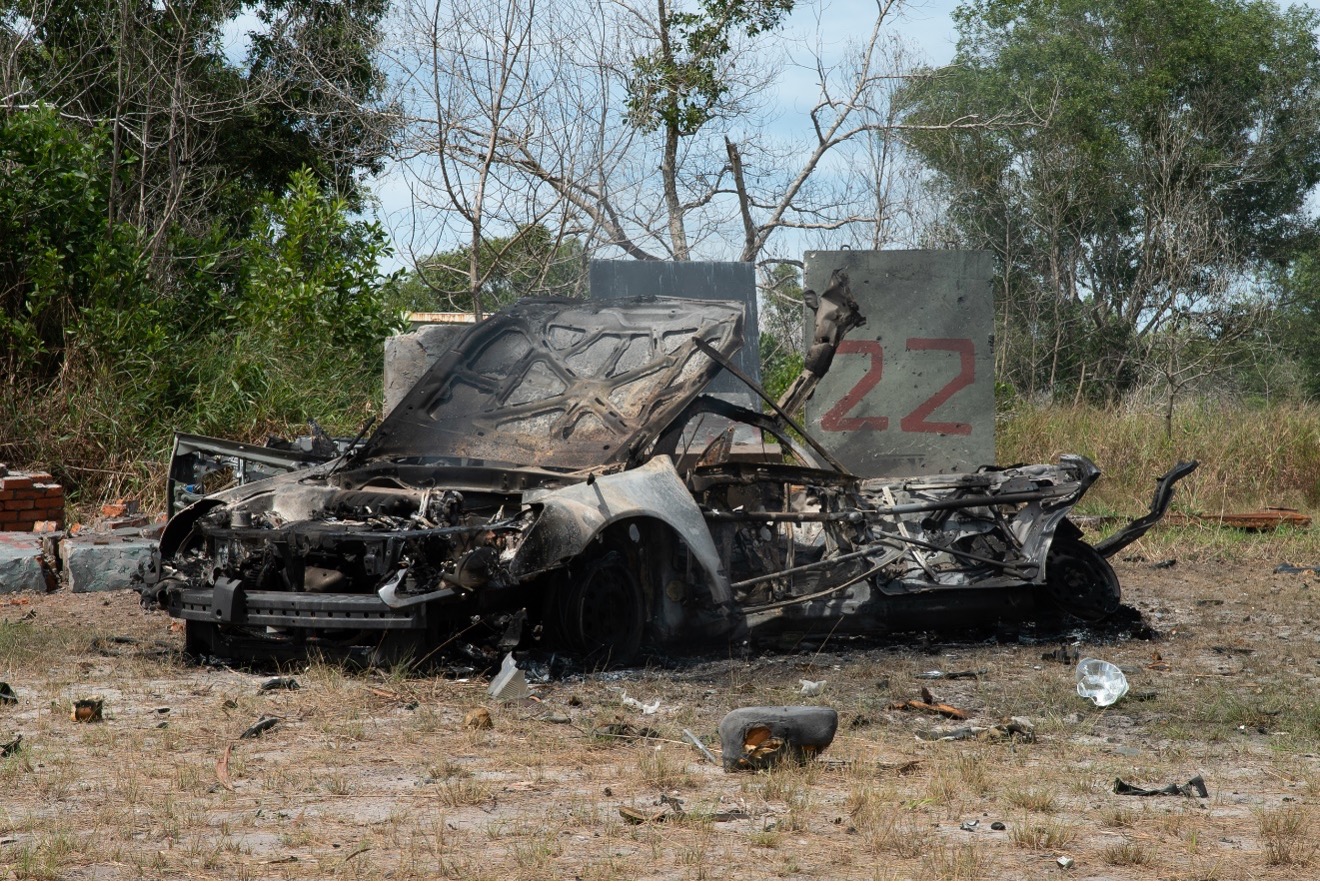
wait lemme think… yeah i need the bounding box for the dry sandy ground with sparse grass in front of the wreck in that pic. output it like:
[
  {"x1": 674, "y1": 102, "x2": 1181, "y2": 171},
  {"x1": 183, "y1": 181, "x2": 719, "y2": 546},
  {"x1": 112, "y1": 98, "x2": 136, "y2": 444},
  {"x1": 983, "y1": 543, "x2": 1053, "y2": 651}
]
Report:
[{"x1": 0, "y1": 533, "x2": 1320, "y2": 879}]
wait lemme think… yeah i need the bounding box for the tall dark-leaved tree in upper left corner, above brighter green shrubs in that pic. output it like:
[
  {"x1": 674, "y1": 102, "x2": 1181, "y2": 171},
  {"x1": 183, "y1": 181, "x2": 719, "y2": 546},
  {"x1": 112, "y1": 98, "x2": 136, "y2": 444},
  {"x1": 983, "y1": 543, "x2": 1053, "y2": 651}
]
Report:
[{"x1": 0, "y1": 0, "x2": 388, "y2": 242}]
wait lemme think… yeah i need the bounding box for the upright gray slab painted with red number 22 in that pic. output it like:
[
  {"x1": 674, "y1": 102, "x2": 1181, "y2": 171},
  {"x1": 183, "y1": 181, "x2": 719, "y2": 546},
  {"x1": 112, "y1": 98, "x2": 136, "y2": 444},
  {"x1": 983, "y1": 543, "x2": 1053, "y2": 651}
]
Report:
[{"x1": 805, "y1": 250, "x2": 995, "y2": 477}]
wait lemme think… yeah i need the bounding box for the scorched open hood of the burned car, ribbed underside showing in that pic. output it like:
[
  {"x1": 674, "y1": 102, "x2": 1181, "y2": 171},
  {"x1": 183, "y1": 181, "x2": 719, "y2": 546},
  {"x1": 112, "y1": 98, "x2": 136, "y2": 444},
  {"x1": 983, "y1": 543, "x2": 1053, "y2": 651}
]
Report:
[{"x1": 355, "y1": 296, "x2": 743, "y2": 469}]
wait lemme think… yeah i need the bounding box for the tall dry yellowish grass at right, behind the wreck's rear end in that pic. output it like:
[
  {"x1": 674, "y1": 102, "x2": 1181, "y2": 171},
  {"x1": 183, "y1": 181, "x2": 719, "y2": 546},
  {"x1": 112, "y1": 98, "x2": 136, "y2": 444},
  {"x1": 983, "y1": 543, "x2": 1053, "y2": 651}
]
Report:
[{"x1": 997, "y1": 403, "x2": 1320, "y2": 514}]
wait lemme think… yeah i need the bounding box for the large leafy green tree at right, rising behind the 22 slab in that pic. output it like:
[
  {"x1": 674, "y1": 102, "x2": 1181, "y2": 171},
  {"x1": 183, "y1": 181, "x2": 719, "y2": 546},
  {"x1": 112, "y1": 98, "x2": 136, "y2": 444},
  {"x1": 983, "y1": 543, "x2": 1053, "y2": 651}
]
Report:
[{"x1": 906, "y1": 0, "x2": 1320, "y2": 393}]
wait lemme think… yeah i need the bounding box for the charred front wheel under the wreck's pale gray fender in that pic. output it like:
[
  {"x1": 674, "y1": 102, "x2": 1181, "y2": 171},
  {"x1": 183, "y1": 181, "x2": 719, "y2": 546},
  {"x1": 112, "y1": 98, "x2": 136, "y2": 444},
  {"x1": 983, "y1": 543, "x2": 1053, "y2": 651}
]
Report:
[{"x1": 554, "y1": 551, "x2": 647, "y2": 668}]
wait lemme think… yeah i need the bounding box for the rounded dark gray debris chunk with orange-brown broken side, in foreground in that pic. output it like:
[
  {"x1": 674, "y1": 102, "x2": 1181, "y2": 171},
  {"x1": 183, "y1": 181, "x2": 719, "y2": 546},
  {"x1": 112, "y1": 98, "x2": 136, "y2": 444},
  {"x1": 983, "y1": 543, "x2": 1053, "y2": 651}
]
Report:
[{"x1": 719, "y1": 706, "x2": 838, "y2": 772}]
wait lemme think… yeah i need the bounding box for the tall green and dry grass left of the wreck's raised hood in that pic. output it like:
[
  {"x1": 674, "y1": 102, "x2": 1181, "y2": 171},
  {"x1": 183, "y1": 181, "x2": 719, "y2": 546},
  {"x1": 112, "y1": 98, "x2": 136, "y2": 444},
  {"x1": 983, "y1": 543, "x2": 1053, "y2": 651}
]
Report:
[{"x1": 0, "y1": 334, "x2": 381, "y2": 522}]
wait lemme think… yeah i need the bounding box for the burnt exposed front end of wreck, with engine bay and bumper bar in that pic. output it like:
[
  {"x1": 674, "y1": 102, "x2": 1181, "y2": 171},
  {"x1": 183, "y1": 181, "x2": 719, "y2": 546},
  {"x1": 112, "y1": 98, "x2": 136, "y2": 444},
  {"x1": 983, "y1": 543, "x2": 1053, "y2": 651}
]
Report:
[{"x1": 158, "y1": 480, "x2": 532, "y2": 630}]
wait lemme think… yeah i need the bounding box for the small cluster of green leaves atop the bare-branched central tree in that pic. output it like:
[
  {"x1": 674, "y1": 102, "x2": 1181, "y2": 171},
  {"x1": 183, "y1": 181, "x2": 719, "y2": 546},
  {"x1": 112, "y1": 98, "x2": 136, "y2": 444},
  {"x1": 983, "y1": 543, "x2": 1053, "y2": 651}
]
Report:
[{"x1": 626, "y1": 0, "x2": 795, "y2": 136}]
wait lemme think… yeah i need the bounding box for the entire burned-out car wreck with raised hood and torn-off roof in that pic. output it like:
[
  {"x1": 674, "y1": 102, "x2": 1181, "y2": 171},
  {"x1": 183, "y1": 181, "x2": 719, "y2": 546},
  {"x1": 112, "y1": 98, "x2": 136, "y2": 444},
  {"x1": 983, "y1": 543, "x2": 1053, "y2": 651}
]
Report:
[{"x1": 141, "y1": 287, "x2": 1195, "y2": 663}]
